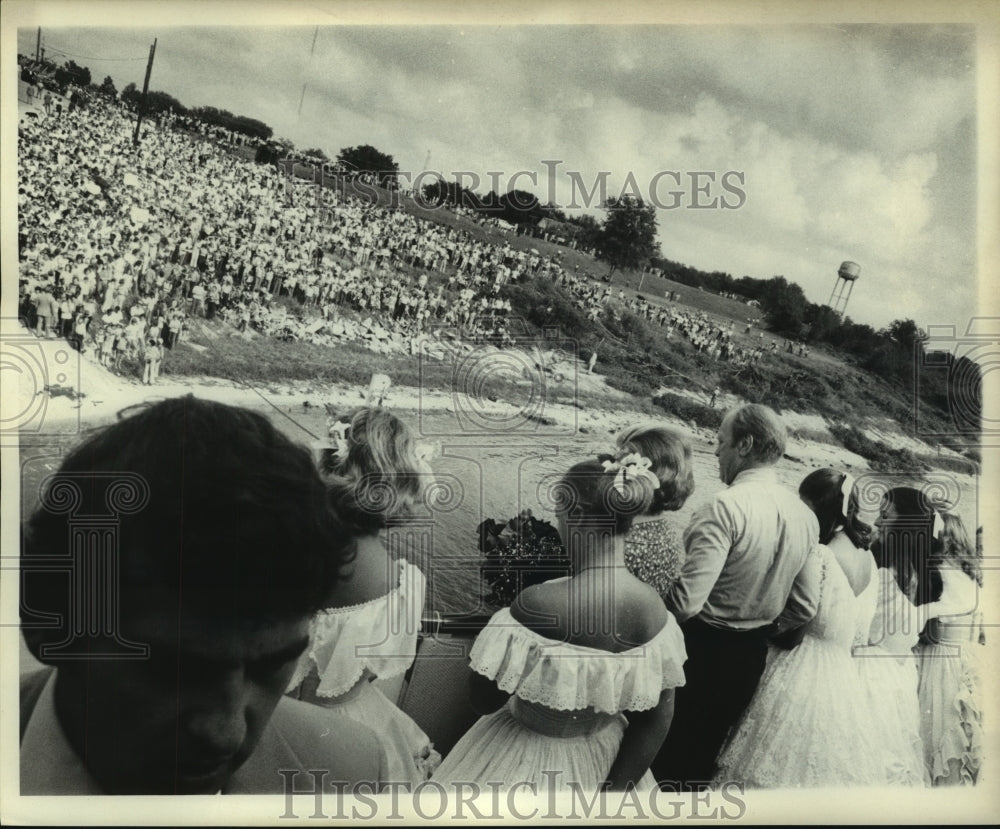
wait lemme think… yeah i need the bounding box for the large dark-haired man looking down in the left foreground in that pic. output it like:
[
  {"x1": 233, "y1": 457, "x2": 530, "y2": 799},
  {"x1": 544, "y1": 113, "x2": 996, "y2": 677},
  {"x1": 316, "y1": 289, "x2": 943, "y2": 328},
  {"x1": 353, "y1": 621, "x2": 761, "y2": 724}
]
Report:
[{"x1": 21, "y1": 396, "x2": 385, "y2": 795}]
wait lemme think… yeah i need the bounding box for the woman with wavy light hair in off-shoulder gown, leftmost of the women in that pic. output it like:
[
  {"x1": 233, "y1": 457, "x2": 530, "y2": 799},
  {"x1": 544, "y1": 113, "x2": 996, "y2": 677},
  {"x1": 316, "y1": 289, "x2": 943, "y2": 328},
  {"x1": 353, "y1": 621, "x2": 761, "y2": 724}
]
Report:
[{"x1": 289, "y1": 409, "x2": 440, "y2": 786}]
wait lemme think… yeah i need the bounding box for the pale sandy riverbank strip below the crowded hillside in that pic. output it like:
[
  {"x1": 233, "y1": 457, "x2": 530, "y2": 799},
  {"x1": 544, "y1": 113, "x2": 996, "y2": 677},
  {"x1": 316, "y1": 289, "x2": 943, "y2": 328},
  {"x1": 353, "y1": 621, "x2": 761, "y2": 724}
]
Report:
[{"x1": 11, "y1": 308, "x2": 972, "y2": 479}]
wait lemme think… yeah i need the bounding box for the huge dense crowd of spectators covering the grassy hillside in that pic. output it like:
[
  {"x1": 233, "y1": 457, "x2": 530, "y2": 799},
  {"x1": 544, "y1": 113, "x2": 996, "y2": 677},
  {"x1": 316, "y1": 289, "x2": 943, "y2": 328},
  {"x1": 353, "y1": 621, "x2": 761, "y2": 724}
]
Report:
[{"x1": 18, "y1": 71, "x2": 796, "y2": 380}]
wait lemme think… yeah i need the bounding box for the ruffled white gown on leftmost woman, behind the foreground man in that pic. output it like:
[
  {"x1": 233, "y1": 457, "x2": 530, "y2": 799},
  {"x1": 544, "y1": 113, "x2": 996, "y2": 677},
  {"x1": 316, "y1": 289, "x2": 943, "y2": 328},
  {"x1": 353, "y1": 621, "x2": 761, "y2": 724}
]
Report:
[{"x1": 288, "y1": 560, "x2": 441, "y2": 786}]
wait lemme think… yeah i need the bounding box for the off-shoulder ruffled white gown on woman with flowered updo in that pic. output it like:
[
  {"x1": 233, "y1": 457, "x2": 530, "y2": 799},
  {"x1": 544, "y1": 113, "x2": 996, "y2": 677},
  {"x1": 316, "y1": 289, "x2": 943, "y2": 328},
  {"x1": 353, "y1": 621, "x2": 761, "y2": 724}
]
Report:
[{"x1": 432, "y1": 608, "x2": 687, "y2": 791}]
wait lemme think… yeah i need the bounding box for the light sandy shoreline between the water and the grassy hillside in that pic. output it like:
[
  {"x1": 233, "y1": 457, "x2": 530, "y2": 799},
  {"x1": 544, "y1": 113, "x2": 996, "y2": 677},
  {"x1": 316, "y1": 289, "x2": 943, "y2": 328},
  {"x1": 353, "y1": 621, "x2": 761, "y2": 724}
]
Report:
[{"x1": 3, "y1": 316, "x2": 932, "y2": 478}]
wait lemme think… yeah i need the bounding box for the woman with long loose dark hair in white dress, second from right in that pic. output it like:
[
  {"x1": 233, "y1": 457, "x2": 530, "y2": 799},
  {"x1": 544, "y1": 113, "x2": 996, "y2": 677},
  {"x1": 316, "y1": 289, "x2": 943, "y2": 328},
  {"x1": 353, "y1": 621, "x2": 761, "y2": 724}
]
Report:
[{"x1": 855, "y1": 487, "x2": 941, "y2": 787}]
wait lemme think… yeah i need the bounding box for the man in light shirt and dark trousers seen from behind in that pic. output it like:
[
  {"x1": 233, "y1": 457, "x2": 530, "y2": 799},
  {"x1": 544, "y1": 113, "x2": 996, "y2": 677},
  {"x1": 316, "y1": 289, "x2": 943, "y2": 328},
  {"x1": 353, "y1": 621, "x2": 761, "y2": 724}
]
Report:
[{"x1": 651, "y1": 404, "x2": 819, "y2": 788}]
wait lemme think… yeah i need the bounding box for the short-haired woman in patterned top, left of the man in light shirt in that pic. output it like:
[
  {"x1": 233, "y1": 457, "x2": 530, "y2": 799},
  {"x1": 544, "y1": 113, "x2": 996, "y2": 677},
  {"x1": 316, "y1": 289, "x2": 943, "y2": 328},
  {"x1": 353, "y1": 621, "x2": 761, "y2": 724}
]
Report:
[{"x1": 617, "y1": 424, "x2": 694, "y2": 596}]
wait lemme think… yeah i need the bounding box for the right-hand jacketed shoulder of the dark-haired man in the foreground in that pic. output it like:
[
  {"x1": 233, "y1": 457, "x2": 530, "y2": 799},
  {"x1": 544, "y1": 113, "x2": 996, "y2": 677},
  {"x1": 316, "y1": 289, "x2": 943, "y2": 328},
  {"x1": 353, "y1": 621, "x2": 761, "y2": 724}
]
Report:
[{"x1": 226, "y1": 697, "x2": 385, "y2": 794}]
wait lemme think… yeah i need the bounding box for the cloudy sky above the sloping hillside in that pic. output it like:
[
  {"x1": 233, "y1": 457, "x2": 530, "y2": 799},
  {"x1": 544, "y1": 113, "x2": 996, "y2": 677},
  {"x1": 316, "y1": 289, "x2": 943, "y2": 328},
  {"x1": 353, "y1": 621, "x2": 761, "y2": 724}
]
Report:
[{"x1": 17, "y1": 16, "x2": 977, "y2": 329}]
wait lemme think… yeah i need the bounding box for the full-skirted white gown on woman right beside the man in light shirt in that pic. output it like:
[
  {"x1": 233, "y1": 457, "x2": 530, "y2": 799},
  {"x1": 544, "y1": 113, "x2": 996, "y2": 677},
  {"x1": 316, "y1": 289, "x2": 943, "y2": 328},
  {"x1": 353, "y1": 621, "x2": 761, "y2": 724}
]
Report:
[{"x1": 715, "y1": 545, "x2": 883, "y2": 788}]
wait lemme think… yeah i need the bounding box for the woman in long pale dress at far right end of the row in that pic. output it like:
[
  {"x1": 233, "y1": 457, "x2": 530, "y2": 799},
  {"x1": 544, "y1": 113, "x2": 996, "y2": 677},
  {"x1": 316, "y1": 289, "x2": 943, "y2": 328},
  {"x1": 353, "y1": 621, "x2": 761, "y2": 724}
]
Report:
[{"x1": 917, "y1": 513, "x2": 983, "y2": 786}]
